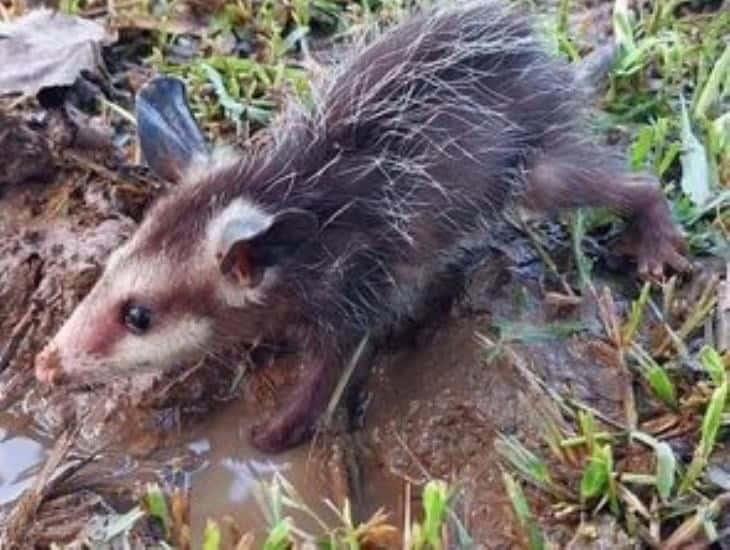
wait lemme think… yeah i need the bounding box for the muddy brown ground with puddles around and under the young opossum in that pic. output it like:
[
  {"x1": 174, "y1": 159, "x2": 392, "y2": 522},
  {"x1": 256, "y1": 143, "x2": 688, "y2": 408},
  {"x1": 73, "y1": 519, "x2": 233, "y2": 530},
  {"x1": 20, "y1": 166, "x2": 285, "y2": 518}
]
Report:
[{"x1": 0, "y1": 1, "x2": 723, "y2": 548}]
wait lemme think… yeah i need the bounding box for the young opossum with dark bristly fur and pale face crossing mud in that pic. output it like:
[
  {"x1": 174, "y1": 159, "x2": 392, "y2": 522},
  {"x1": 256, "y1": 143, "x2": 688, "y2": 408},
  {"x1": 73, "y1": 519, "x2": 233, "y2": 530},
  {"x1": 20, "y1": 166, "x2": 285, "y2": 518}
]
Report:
[{"x1": 36, "y1": 0, "x2": 688, "y2": 451}]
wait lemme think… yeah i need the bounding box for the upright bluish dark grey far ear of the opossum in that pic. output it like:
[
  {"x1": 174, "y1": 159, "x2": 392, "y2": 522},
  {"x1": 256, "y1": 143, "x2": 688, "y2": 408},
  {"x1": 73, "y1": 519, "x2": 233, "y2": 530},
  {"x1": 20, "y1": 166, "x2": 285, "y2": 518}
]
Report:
[{"x1": 136, "y1": 77, "x2": 209, "y2": 182}]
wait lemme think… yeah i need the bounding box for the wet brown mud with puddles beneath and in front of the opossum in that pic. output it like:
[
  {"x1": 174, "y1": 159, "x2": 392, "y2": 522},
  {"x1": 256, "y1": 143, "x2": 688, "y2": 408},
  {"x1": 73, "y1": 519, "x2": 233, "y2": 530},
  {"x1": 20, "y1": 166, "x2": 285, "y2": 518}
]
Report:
[{"x1": 0, "y1": 143, "x2": 636, "y2": 548}]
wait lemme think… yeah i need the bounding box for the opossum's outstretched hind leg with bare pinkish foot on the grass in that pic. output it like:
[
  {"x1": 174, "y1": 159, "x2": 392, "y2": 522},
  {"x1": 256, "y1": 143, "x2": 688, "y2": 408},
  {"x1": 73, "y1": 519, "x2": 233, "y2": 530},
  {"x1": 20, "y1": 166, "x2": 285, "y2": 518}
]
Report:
[{"x1": 524, "y1": 144, "x2": 690, "y2": 279}]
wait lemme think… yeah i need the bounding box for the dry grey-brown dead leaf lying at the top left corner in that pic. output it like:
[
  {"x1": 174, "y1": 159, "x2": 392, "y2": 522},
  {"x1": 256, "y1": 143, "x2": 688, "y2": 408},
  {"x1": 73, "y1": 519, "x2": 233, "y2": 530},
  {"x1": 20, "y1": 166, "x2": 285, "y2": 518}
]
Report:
[{"x1": 0, "y1": 9, "x2": 116, "y2": 95}]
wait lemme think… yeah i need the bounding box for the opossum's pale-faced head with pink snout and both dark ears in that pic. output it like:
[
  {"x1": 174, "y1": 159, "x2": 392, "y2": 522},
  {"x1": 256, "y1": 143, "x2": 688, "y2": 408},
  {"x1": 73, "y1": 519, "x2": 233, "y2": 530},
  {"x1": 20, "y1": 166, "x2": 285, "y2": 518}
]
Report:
[{"x1": 35, "y1": 79, "x2": 316, "y2": 382}]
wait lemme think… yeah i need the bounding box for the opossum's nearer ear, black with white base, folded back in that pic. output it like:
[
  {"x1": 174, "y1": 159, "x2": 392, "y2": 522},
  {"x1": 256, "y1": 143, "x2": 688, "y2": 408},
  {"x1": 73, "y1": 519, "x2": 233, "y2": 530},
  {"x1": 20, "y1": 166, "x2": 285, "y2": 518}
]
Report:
[{"x1": 220, "y1": 209, "x2": 319, "y2": 287}]
